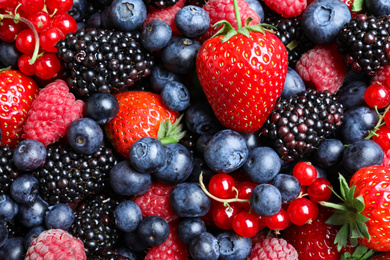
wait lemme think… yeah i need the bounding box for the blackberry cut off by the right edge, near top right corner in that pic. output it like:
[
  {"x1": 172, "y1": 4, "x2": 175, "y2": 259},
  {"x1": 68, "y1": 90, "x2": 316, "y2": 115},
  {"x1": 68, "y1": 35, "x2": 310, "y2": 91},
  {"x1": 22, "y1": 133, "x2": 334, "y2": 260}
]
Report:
[{"x1": 336, "y1": 14, "x2": 390, "y2": 76}]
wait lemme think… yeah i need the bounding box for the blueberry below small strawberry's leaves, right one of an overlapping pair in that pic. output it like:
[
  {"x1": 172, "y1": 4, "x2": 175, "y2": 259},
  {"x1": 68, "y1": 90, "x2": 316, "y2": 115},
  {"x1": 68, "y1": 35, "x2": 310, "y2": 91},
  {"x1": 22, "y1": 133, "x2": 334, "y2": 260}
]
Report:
[{"x1": 153, "y1": 143, "x2": 194, "y2": 185}]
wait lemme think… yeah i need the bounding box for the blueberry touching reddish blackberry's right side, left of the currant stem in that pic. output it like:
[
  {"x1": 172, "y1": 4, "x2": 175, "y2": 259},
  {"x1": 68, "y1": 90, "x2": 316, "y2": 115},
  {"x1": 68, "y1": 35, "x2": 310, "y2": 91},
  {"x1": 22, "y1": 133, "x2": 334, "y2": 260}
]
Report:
[{"x1": 338, "y1": 106, "x2": 379, "y2": 144}]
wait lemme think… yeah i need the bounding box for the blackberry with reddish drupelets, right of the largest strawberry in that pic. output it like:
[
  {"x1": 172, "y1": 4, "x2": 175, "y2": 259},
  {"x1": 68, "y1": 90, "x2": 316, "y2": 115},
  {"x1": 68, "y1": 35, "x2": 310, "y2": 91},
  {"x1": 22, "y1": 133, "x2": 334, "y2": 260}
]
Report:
[{"x1": 262, "y1": 89, "x2": 343, "y2": 161}]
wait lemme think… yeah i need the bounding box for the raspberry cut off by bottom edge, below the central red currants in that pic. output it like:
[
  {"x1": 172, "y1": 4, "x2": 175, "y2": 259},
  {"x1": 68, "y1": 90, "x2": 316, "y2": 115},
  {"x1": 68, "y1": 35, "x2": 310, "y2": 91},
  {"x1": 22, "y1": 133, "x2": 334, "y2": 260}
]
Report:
[{"x1": 248, "y1": 238, "x2": 298, "y2": 260}]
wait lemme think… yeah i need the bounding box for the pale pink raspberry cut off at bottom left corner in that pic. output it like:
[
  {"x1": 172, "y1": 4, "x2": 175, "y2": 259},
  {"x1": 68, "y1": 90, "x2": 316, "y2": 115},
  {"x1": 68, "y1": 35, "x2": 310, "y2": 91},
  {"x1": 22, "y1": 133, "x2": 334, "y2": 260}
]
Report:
[{"x1": 25, "y1": 229, "x2": 87, "y2": 260}]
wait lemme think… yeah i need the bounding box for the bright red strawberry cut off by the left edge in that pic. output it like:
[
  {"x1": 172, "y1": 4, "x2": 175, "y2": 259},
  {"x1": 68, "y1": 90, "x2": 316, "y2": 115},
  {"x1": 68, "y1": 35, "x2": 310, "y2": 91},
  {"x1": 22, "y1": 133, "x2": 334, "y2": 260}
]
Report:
[{"x1": 0, "y1": 70, "x2": 39, "y2": 148}]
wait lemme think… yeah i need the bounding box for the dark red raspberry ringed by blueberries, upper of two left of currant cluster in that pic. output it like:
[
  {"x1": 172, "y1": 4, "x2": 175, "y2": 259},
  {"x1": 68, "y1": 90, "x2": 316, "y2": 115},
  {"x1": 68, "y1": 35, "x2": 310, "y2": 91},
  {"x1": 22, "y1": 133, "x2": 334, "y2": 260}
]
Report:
[{"x1": 134, "y1": 182, "x2": 179, "y2": 222}]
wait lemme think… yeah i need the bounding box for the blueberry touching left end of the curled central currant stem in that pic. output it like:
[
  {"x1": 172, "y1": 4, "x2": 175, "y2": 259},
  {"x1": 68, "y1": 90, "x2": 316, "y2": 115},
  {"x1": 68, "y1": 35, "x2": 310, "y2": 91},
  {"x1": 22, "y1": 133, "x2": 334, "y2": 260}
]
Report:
[{"x1": 169, "y1": 182, "x2": 211, "y2": 217}]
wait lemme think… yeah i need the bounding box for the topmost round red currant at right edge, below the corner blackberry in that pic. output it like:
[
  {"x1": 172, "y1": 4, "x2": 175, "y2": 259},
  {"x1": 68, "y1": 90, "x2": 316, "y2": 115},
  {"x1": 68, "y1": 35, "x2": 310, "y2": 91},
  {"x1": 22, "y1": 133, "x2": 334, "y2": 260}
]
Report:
[{"x1": 364, "y1": 84, "x2": 390, "y2": 109}]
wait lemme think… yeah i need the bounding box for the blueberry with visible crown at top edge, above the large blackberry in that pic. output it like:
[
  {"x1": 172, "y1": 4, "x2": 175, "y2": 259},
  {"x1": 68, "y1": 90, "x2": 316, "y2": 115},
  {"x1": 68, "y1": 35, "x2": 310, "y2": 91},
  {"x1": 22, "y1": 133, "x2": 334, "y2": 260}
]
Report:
[{"x1": 108, "y1": 0, "x2": 147, "y2": 32}]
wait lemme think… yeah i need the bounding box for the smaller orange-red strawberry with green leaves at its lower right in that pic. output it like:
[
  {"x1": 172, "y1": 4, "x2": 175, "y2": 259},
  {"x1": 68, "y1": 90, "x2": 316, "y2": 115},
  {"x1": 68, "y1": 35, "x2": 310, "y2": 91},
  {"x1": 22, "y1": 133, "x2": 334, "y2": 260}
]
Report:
[{"x1": 105, "y1": 91, "x2": 184, "y2": 158}]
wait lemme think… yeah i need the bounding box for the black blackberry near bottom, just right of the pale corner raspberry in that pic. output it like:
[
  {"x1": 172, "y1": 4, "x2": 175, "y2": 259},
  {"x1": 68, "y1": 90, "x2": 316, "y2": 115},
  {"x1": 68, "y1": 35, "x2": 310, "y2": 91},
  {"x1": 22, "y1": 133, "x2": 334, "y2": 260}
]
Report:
[{"x1": 69, "y1": 195, "x2": 119, "y2": 259}]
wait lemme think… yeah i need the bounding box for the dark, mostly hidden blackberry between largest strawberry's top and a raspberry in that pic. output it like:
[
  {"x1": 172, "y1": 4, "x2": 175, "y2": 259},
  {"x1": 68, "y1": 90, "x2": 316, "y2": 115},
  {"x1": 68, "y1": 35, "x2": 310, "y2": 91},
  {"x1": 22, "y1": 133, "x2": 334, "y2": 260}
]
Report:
[{"x1": 264, "y1": 16, "x2": 315, "y2": 68}]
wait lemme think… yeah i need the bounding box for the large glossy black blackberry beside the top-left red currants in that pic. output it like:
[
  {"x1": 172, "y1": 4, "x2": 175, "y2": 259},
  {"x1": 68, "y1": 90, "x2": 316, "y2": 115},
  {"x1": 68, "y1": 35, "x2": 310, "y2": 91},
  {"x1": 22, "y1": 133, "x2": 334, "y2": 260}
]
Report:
[{"x1": 57, "y1": 28, "x2": 154, "y2": 97}]
